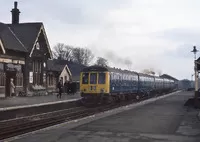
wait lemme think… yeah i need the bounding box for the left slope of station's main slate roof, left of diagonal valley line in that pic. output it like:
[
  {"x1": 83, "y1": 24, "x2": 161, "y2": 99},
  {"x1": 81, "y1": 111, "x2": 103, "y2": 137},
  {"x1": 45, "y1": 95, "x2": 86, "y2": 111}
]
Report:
[{"x1": 0, "y1": 23, "x2": 27, "y2": 52}]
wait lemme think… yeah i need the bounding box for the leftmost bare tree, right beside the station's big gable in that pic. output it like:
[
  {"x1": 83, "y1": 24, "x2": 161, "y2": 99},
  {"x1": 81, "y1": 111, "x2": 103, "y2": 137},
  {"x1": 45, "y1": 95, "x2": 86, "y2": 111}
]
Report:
[{"x1": 53, "y1": 43, "x2": 73, "y2": 60}]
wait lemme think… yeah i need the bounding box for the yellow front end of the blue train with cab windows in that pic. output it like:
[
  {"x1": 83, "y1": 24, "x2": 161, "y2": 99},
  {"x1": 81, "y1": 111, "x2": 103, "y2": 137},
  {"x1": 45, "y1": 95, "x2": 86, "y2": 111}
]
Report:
[{"x1": 80, "y1": 72, "x2": 110, "y2": 96}]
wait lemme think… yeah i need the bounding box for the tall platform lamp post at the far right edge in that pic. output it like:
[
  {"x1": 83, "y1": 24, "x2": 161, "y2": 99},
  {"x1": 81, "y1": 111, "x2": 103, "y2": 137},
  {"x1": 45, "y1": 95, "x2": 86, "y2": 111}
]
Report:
[{"x1": 191, "y1": 46, "x2": 199, "y2": 106}]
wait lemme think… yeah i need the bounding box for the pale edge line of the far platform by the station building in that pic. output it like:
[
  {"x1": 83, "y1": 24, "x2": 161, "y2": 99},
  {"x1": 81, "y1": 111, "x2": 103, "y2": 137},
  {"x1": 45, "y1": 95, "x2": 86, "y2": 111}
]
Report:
[{"x1": 0, "y1": 98, "x2": 80, "y2": 111}]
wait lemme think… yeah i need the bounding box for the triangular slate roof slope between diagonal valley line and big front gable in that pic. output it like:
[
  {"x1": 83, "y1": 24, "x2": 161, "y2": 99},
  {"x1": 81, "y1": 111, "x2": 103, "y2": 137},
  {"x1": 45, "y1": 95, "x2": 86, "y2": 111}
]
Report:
[{"x1": 7, "y1": 22, "x2": 43, "y2": 52}]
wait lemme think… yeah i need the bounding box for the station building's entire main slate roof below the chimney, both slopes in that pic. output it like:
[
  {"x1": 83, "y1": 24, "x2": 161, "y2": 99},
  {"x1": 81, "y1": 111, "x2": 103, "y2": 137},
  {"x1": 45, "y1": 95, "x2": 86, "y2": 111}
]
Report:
[{"x1": 0, "y1": 22, "x2": 48, "y2": 52}]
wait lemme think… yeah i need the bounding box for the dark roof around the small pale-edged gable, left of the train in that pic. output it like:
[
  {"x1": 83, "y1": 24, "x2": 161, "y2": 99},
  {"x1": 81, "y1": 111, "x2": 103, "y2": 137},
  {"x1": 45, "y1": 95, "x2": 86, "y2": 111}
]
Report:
[{"x1": 47, "y1": 59, "x2": 86, "y2": 81}]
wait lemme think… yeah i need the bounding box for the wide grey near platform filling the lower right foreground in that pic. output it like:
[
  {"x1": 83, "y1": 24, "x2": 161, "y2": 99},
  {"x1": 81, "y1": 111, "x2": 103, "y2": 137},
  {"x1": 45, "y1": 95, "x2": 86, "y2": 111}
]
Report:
[{"x1": 10, "y1": 92, "x2": 200, "y2": 142}]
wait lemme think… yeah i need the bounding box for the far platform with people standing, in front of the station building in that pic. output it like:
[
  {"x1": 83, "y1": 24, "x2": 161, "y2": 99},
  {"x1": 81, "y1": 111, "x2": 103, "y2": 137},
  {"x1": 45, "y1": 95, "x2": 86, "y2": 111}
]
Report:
[{"x1": 0, "y1": 93, "x2": 80, "y2": 111}]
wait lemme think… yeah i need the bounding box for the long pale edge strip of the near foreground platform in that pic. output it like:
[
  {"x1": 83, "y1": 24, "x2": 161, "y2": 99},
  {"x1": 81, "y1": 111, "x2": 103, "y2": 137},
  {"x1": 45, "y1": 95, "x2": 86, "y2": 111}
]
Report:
[{"x1": 4, "y1": 91, "x2": 181, "y2": 142}]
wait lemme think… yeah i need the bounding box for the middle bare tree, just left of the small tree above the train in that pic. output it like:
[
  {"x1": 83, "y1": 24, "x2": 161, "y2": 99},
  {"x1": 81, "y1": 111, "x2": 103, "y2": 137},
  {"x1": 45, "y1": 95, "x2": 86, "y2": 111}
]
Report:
[{"x1": 72, "y1": 47, "x2": 94, "y2": 66}]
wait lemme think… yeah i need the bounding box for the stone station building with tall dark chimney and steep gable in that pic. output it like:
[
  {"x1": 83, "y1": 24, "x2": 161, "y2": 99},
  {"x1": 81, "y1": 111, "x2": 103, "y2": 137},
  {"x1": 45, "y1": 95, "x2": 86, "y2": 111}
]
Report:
[{"x1": 0, "y1": 2, "x2": 52, "y2": 96}]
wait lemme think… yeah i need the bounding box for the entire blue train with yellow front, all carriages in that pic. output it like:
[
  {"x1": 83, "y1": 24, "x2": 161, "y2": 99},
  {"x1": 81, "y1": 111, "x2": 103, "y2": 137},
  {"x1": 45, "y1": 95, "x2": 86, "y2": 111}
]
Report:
[{"x1": 80, "y1": 65, "x2": 176, "y2": 105}]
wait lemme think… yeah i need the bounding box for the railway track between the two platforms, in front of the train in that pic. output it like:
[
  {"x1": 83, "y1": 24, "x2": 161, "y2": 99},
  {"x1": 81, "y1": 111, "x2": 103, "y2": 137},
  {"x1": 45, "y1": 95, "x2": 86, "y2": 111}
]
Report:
[{"x1": 0, "y1": 91, "x2": 173, "y2": 140}]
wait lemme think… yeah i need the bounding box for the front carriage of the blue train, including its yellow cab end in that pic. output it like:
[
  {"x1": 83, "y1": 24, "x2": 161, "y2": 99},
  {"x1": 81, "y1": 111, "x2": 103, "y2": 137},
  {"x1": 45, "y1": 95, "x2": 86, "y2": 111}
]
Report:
[{"x1": 80, "y1": 66, "x2": 138, "y2": 103}]
